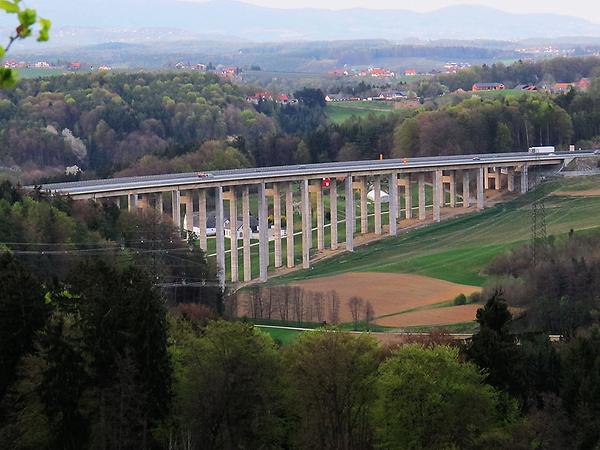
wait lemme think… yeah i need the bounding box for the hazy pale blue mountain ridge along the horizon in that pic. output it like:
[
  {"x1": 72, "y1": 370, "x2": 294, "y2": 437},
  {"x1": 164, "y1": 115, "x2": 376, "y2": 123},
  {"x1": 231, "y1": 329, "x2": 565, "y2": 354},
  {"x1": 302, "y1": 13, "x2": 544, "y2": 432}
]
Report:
[{"x1": 7, "y1": 0, "x2": 600, "y2": 41}]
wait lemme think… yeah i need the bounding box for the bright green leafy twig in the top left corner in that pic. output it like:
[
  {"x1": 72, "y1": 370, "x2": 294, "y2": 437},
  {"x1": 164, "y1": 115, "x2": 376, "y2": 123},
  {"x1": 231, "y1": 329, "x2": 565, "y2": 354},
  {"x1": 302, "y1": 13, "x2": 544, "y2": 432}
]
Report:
[{"x1": 0, "y1": 0, "x2": 51, "y2": 89}]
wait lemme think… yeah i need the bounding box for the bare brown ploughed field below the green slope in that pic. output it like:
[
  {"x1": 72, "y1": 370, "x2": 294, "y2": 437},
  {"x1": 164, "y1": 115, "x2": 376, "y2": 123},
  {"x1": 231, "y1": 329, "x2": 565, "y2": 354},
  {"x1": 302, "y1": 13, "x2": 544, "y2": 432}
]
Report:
[{"x1": 293, "y1": 272, "x2": 479, "y2": 326}]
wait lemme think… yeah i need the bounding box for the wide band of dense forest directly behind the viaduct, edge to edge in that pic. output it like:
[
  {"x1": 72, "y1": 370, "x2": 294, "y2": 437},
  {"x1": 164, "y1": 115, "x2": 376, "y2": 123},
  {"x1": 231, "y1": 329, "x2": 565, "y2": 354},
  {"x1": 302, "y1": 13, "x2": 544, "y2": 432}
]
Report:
[{"x1": 0, "y1": 58, "x2": 600, "y2": 182}]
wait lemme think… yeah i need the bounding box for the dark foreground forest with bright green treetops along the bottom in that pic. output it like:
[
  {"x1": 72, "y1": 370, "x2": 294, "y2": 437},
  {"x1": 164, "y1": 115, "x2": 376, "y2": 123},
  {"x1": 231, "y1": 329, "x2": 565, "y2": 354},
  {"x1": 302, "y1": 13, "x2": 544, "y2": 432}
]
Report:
[{"x1": 0, "y1": 183, "x2": 600, "y2": 450}]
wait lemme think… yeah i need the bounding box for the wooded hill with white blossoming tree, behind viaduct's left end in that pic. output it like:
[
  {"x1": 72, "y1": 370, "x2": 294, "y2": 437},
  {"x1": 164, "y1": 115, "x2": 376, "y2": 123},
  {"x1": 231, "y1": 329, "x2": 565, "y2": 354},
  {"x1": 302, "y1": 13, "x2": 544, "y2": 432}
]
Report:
[{"x1": 0, "y1": 73, "x2": 275, "y2": 175}]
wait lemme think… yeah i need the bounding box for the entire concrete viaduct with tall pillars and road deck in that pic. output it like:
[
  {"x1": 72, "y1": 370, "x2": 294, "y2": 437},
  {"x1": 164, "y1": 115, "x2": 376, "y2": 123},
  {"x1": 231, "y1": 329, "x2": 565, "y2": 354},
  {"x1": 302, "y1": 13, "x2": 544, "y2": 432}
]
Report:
[{"x1": 34, "y1": 151, "x2": 593, "y2": 287}]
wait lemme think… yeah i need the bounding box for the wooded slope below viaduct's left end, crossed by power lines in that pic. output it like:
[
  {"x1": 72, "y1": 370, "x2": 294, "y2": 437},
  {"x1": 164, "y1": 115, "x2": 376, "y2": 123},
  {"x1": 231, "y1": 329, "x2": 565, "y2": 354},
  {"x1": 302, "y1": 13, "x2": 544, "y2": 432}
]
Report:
[{"x1": 0, "y1": 182, "x2": 222, "y2": 306}]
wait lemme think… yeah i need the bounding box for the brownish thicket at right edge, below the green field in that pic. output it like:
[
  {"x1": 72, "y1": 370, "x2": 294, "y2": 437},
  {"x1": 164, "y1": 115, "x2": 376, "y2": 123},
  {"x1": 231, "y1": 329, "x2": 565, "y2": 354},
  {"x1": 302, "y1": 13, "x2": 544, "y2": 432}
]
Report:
[{"x1": 488, "y1": 232, "x2": 600, "y2": 336}]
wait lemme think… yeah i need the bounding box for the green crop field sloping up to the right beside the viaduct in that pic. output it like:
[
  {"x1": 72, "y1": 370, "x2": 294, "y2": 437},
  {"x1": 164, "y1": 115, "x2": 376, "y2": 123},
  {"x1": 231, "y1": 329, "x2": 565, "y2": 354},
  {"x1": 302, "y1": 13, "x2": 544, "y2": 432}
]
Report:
[{"x1": 272, "y1": 177, "x2": 600, "y2": 285}]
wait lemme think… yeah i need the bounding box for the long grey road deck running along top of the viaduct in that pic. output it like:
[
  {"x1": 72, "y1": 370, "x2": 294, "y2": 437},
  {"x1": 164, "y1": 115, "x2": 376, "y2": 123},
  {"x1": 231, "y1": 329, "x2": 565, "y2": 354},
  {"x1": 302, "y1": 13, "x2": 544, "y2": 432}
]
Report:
[{"x1": 29, "y1": 150, "x2": 594, "y2": 196}]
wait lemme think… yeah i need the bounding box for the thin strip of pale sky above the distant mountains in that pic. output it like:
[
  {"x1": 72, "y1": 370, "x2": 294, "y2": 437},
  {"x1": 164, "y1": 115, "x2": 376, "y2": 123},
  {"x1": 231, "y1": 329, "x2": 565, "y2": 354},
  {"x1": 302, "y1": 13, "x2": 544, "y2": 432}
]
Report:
[{"x1": 196, "y1": 0, "x2": 600, "y2": 23}]
